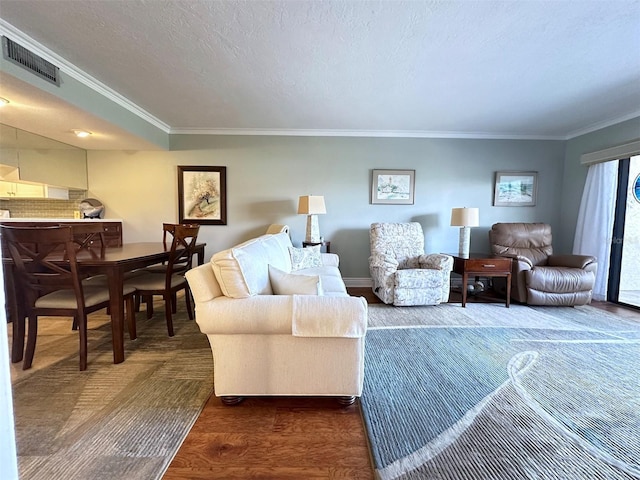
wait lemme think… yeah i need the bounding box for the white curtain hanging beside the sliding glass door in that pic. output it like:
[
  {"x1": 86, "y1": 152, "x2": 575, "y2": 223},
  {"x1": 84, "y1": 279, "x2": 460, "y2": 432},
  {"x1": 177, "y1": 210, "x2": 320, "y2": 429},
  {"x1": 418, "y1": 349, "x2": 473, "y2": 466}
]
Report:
[{"x1": 573, "y1": 161, "x2": 618, "y2": 300}]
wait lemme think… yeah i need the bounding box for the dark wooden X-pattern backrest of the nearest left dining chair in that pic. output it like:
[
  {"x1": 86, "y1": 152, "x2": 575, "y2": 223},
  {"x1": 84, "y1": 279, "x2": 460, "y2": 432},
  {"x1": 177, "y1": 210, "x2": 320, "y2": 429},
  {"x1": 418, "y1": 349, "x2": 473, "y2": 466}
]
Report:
[{"x1": 2, "y1": 226, "x2": 84, "y2": 309}]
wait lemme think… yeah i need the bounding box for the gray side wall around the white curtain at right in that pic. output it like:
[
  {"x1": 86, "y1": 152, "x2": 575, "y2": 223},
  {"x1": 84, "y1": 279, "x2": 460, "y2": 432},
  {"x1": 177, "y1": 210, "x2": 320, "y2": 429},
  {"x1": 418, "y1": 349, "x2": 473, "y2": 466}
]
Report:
[{"x1": 554, "y1": 117, "x2": 640, "y2": 252}]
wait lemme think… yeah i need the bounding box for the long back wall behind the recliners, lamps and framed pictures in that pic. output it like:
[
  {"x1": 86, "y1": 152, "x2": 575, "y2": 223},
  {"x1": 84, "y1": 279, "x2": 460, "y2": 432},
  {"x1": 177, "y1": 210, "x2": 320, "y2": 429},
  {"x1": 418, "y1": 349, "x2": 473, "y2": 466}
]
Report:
[{"x1": 88, "y1": 135, "x2": 565, "y2": 284}]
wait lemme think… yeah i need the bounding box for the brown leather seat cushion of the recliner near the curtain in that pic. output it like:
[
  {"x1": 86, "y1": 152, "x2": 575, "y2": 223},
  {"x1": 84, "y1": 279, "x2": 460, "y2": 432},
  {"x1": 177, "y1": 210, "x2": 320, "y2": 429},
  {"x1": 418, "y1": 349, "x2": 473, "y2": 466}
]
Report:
[{"x1": 525, "y1": 266, "x2": 594, "y2": 294}]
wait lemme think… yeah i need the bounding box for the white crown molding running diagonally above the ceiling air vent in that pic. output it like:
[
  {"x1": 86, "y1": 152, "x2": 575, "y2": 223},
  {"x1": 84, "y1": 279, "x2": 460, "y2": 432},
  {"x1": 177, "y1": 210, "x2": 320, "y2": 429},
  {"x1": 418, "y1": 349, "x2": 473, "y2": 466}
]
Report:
[{"x1": 0, "y1": 18, "x2": 170, "y2": 134}]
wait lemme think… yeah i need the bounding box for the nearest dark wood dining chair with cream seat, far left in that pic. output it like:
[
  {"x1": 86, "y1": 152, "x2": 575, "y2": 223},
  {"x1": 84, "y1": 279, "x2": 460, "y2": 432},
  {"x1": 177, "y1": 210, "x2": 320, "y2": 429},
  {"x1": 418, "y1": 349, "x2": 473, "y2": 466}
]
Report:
[{"x1": 0, "y1": 225, "x2": 135, "y2": 370}]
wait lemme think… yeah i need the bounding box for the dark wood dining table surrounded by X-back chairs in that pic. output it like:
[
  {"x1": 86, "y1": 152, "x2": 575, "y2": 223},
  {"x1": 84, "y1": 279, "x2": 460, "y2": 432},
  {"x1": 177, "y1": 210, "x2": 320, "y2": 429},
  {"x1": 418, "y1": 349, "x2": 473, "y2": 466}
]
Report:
[{"x1": 5, "y1": 242, "x2": 206, "y2": 363}]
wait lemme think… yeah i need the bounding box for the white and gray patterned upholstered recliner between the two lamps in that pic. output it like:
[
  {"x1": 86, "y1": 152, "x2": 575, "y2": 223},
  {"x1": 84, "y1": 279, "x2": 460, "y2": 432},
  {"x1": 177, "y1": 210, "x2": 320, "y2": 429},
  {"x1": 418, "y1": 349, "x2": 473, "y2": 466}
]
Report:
[{"x1": 369, "y1": 222, "x2": 453, "y2": 306}]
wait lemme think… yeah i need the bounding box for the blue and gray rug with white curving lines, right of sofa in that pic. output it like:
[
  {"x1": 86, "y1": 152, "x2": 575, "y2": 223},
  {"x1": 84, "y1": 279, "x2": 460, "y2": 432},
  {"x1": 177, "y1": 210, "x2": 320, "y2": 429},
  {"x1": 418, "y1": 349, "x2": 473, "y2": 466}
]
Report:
[{"x1": 361, "y1": 304, "x2": 640, "y2": 480}]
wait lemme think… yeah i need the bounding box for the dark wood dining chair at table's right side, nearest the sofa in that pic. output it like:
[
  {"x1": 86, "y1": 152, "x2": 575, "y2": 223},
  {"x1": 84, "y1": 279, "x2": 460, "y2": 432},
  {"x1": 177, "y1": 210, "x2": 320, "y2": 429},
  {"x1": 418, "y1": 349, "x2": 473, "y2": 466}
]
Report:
[{"x1": 125, "y1": 224, "x2": 200, "y2": 337}]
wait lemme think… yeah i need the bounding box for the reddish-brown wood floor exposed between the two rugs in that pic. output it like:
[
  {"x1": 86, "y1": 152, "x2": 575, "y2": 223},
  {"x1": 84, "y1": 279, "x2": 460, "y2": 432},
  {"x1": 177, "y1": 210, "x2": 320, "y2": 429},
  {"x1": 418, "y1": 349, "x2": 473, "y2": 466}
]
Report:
[{"x1": 163, "y1": 288, "x2": 640, "y2": 480}]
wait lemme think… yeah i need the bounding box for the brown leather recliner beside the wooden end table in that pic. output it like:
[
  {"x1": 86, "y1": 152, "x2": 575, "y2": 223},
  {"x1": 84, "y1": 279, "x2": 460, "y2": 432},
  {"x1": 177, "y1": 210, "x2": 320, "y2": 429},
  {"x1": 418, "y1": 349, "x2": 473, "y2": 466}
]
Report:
[{"x1": 489, "y1": 223, "x2": 598, "y2": 306}]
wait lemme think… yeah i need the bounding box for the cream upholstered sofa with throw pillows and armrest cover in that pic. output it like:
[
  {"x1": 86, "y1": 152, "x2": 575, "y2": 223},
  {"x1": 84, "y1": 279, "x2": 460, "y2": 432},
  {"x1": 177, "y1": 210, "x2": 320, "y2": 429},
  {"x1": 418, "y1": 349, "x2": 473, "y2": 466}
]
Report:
[{"x1": 187, "y1": 233, "x2": 367, "y2": 404}]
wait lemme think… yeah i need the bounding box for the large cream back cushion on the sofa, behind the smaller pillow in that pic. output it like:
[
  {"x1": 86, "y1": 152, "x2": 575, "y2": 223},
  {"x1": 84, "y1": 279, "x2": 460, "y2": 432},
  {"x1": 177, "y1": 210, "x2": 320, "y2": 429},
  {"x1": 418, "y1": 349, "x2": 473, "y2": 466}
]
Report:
[{"x1": 211, "y1": 233, "x2": 291, "y2": 298}]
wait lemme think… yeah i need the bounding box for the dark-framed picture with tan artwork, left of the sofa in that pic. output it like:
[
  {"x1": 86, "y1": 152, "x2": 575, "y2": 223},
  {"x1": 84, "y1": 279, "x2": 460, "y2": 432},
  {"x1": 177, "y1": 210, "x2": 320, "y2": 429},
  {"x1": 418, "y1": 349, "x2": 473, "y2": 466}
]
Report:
[{"x1": 178, "y1": 165, "x2": 227, "y2": 225}]
